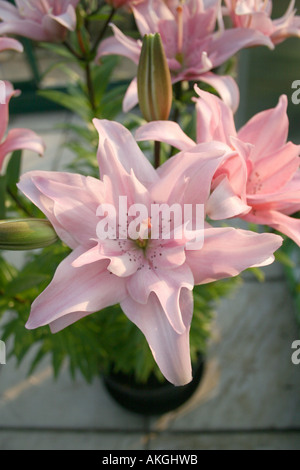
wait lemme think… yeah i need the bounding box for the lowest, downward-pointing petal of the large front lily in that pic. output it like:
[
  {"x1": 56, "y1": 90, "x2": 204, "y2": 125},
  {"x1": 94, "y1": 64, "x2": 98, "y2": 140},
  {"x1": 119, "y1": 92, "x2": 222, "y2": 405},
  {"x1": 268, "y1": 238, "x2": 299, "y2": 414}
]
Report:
[{"x1": 121, "y1": 289, "x2": 193, "y2": 386}]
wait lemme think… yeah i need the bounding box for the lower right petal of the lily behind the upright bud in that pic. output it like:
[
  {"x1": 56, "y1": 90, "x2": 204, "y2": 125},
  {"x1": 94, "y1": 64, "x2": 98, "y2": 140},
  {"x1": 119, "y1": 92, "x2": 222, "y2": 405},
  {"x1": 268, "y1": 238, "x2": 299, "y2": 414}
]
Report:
[{"x1": 200, "y1": 72, "x2": 240, "y2": 113}]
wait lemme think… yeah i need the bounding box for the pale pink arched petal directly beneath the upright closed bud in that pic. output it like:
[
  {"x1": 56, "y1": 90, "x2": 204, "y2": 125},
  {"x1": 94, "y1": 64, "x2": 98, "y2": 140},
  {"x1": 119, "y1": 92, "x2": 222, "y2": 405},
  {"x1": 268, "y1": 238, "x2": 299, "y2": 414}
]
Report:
[{"x1": 135, "y1": 121, "x2": 200, "y2": 150}]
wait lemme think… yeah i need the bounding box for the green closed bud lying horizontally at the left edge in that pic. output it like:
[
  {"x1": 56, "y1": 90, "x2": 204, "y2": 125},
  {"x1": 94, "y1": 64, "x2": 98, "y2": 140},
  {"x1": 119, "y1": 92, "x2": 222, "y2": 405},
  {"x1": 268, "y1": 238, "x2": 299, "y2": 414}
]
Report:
[{"x1": 0, "y1": 219, "x2": 58, "y2": 251}]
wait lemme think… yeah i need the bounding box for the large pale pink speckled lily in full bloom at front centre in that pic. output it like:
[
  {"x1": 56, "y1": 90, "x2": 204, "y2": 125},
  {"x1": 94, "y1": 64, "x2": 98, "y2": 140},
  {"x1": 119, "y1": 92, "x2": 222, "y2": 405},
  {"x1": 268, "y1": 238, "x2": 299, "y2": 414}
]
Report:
[{"x1": 18, "y1": 119, "x2": 282, "y2": 385}]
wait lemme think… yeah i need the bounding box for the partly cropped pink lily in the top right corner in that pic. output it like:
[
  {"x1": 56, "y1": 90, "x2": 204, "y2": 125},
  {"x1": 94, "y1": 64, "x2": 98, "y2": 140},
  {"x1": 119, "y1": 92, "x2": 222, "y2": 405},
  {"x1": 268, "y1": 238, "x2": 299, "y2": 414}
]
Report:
[{"x1": 224, "y1": 0, "x2": 300, "y2": 44}]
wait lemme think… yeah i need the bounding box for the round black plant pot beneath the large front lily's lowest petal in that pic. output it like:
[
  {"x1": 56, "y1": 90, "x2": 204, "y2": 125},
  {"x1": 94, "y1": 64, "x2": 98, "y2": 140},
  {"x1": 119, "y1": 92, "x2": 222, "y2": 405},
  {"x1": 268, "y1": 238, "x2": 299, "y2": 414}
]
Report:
[{"x1": 103, "y1": 356, "x2": 204, "y2": 416}]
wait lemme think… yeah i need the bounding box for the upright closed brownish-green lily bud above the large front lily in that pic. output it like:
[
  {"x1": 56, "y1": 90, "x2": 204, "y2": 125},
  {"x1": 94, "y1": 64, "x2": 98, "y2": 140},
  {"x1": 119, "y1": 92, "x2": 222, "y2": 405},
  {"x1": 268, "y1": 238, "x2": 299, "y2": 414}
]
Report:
[{"x1": 137, "y1": 33, "x2": 173, "y2": 122}]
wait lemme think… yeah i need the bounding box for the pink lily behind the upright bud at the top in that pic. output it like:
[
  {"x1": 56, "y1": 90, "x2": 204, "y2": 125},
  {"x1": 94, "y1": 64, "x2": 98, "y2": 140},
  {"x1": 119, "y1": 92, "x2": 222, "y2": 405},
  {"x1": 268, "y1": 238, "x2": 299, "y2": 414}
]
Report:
[{"x1": 97, "y1": 0, "x2": 274, "y2": 112}]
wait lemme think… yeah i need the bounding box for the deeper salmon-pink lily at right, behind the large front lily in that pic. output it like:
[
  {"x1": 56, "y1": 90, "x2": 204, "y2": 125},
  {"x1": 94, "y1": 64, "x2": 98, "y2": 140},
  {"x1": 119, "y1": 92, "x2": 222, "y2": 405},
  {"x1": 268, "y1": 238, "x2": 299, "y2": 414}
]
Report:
[{"x1": 136, "y1": 88, "x2": 300, "y2": 246}]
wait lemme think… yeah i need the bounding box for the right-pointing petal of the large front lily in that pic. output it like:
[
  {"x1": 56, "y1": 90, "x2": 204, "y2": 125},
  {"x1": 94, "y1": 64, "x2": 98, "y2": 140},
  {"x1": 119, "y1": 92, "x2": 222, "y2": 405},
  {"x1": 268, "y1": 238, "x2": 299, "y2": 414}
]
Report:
[{"x1": 186, "y1": 227, "x2": 282, "y2": 284}]
